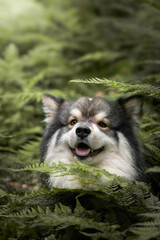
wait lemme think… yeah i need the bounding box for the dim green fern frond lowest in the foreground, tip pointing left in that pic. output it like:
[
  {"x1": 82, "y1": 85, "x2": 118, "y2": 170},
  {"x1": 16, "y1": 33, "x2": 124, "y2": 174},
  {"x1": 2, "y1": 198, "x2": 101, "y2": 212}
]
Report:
[{"x1": 6, "y1": 204, "x2": 120, "y2": 239}]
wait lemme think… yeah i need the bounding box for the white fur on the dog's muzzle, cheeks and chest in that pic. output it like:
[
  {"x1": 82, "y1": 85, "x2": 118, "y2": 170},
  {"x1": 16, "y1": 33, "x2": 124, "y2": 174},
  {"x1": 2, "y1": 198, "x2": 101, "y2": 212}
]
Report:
[{"x1": 45, "y1": 124, "x2": 136, "y2": 188}]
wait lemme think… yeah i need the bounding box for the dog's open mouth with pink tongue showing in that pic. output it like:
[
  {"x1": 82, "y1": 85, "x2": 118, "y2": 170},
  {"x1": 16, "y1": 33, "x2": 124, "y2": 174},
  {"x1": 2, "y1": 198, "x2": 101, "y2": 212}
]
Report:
[{"x1": 71, "y1": 143, "x2": 104, "y2": 159}]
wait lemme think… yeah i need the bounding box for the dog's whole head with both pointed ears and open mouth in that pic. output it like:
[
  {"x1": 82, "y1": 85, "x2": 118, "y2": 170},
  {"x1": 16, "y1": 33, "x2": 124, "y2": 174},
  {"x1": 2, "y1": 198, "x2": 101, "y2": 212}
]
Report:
[{"x1": 43, "y1": 94, "x2": 142, "y2": 170}]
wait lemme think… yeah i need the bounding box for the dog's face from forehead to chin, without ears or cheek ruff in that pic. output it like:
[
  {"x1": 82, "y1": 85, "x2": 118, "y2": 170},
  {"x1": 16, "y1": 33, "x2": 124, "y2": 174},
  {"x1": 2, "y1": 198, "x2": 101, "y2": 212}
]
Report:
[{"x1": 59, "y1": 97, "x2": 120, "y2": 165}]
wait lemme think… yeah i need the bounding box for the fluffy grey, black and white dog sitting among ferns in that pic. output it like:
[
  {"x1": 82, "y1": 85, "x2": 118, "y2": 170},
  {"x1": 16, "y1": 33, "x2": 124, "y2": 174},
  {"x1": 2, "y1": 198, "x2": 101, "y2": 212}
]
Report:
[{"x1": 41, "y1": 94, "x2": 145, "y2": 189}]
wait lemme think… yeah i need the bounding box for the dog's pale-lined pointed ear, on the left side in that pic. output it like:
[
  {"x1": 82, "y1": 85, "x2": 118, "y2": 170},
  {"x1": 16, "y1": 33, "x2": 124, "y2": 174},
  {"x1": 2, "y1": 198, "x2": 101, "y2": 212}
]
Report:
[{"x1": 42, "y1": 94, "x2": 66, "y2": 124}]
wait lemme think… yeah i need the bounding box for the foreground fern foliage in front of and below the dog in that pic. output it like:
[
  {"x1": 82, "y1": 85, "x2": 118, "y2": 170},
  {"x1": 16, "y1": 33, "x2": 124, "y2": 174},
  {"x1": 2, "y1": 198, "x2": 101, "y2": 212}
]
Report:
[{"x1": 0, "y1": 163, "x2": 160, "y2": 239}]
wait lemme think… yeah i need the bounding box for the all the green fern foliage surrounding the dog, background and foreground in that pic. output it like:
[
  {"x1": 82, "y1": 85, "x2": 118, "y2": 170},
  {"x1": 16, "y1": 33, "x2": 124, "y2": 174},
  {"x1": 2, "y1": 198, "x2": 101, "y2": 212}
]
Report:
[{"x1": 0, "y1": 0, "x2": 160, "y2": 240}]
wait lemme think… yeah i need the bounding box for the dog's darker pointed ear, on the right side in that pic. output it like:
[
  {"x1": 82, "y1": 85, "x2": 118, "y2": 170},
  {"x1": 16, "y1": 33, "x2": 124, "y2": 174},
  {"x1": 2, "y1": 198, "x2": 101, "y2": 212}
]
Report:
[{"x1": 118, "y1": 95, "x2": 143, "y2": 127}]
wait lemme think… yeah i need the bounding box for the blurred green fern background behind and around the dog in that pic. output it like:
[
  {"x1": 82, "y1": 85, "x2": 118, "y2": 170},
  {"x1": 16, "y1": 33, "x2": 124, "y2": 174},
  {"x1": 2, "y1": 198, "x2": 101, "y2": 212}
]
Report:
[{"x1": 0, "y1": 0, "x2": 160, "y2": 239}]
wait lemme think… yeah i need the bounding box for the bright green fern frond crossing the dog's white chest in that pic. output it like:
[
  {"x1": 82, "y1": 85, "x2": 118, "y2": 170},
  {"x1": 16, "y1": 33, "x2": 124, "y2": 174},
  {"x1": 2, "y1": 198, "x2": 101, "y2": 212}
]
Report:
[{"x1": 13, "y1": 161, "x2": 124, "y2": 188}]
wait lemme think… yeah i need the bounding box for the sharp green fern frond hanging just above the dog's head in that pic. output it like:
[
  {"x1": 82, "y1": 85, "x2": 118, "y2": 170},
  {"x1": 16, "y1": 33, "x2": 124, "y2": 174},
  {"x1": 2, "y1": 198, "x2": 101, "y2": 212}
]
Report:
[{"x1": 70, "y1": 78, "x2": 160, "y2": 99}]
